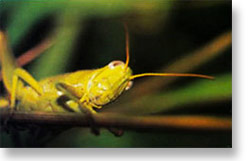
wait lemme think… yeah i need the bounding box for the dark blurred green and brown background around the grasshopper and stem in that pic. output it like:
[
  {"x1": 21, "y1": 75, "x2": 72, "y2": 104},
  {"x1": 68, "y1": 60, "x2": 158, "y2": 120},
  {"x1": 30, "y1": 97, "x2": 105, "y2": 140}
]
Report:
[{"x1": 0, "y1": 0, "x2": 232, "y2": 147}]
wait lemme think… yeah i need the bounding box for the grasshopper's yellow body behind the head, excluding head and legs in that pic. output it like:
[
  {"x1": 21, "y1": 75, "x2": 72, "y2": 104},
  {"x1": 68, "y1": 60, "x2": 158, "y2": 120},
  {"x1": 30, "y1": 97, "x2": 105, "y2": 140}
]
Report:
[{"x1": 16, "y1": 70, "x2": 94, "y2": 112}]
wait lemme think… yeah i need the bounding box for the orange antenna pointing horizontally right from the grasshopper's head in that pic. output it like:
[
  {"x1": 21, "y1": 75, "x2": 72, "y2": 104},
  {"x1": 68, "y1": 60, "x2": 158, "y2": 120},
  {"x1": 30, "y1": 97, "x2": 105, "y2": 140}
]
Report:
[{"x1": 129, "y1": 73, "x2": 214, "y2": 80}]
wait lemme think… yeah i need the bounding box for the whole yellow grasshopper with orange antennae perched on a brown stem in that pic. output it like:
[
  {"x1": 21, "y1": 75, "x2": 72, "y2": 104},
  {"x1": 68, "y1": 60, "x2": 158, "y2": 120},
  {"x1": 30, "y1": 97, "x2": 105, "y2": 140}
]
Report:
[{"x1": 0, "y1": 26, "x2": 213, "y2": 114}]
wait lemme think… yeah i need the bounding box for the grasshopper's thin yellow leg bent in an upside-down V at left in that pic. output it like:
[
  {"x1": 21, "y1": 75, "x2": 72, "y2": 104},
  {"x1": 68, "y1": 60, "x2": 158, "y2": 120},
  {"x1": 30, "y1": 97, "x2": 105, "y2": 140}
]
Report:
[{"x1": 10, "y1": 68, "x2": 43, "y2": 108}]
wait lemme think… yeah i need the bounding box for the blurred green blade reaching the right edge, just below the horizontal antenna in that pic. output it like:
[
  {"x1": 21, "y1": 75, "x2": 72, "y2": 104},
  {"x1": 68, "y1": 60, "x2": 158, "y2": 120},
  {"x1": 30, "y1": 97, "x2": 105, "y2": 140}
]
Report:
[{"x1": 110, "y1": 74, "x2": 232, "y2": 114}]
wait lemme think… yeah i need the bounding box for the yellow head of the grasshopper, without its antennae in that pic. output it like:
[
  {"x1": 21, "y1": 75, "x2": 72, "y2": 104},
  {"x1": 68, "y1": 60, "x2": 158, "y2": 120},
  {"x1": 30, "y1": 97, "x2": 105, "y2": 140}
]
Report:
[{"x1": 88, "y1": 61, "x2": 132, "y2": 106}]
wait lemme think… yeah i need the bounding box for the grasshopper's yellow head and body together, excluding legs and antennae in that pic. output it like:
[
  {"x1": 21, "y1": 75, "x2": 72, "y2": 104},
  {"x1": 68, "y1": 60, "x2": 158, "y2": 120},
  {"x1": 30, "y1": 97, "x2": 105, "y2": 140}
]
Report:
[{"x1": 17, "y1": 65, "x2": 132, "y2": 112}]
